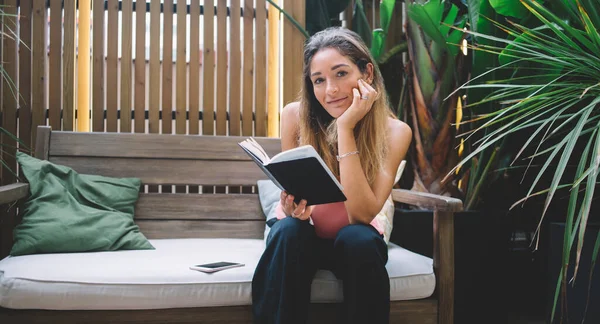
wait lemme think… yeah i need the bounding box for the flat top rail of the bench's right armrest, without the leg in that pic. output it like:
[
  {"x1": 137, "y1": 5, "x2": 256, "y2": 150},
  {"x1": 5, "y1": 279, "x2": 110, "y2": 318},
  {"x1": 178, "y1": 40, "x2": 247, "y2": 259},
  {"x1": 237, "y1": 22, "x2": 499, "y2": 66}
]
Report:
[{"x1": 392, "y1": 189, "x2": 463, "y2": 212}]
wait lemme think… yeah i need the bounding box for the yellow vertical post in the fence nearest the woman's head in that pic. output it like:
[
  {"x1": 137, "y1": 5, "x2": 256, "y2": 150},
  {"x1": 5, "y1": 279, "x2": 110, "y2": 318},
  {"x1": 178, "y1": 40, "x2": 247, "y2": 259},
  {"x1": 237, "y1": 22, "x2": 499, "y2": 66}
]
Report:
[{"x1": 267, "y1": 0, "x2": 280, "y2": 137}]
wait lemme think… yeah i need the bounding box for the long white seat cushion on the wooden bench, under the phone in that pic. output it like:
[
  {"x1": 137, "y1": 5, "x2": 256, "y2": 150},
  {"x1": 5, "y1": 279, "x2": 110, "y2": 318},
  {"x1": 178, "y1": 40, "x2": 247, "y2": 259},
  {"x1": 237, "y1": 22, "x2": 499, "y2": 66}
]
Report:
[{"x1": 0, "y1": 239, "x2": 435, "y2": 310}]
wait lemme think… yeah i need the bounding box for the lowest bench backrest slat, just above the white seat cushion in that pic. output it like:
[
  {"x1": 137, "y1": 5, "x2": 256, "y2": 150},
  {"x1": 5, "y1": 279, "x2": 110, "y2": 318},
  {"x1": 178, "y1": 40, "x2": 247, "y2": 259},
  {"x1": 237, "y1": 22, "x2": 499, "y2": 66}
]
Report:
[{"x1": 136, "y1": 220, "x2": 265, "y2": 239}]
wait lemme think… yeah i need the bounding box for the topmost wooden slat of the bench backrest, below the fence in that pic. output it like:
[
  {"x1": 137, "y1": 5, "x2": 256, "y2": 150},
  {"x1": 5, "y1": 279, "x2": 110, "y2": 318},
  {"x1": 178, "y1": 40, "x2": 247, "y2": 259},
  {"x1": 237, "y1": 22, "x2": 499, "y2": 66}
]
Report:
[{"x1": 50, "y1": 132, "x2": 281, "y2": 161}]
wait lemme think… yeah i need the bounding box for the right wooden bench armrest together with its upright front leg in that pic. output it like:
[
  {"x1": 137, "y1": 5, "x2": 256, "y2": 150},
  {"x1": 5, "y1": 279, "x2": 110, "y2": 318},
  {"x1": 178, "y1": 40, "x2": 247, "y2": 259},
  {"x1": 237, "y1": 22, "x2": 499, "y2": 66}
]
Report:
[{"x1": 392, "y1": 189, "x2": 463, "y2": 324}]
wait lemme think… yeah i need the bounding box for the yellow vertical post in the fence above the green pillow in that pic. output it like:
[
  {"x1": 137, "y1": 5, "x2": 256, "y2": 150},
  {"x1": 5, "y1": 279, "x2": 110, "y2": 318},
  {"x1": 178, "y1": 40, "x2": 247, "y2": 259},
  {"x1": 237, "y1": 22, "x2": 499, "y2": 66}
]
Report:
[{"x1": 77, "y1": 0, "x2": 91, "y2": 132}]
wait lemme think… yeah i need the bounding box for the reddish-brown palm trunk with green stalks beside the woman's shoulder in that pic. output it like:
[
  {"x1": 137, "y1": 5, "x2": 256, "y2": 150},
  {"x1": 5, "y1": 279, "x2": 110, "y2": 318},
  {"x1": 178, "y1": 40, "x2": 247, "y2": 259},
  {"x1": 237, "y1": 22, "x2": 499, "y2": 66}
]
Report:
[{"x1": 406, "y1": 0, "x2": 467, "y2": 194}]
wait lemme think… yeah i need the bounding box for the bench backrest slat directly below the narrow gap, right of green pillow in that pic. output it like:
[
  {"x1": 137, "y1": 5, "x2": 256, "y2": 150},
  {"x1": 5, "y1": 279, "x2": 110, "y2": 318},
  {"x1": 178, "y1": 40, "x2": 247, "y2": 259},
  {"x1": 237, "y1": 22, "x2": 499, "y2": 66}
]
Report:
[{"x1": 135, "y1": 193, "x2": 265, "y2": 221}]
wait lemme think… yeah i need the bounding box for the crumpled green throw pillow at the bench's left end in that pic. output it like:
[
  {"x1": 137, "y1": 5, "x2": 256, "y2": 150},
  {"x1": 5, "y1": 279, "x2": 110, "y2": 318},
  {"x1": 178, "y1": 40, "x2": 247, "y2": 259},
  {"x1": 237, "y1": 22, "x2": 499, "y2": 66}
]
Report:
[{"x1": 10, "y1": 152, "x2": 154, "y2": 256}]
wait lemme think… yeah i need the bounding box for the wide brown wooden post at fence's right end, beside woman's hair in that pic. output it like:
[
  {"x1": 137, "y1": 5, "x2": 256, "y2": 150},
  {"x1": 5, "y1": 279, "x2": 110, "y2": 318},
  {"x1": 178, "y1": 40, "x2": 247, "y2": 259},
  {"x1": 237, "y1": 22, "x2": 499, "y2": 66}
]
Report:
[{"x1": 282, "y1": 0, "x2": 306, "y2": 105}]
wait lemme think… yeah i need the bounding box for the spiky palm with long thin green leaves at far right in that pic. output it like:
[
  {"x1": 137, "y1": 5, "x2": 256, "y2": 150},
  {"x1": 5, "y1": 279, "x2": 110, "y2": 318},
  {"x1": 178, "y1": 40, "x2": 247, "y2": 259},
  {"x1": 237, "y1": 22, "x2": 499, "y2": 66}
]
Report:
[{"x1": 455, "y1": 0, "x2": 600, "y2": 317}]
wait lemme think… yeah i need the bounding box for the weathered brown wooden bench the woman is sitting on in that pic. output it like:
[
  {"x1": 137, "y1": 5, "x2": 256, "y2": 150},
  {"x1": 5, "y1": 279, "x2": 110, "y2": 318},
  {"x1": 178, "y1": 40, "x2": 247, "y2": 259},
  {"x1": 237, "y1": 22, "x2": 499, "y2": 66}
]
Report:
[{"x1": 0, "y1": 127, "x2": 462, "y2": 323}]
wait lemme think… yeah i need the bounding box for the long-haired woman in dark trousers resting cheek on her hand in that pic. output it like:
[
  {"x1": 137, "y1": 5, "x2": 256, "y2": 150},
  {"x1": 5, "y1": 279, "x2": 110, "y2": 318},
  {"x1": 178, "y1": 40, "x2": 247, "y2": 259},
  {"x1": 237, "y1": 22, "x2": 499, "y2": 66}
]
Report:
[{"x1": 252, "y1": 28, "x2": 412, "y2": 323}]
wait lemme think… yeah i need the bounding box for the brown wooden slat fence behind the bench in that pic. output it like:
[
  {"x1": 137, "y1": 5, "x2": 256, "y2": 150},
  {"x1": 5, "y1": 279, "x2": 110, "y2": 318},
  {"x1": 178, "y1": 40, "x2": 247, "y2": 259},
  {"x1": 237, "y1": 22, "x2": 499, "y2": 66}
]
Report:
[{"x1": 0, "y1": 0, "x2": 401, "y2": 256}]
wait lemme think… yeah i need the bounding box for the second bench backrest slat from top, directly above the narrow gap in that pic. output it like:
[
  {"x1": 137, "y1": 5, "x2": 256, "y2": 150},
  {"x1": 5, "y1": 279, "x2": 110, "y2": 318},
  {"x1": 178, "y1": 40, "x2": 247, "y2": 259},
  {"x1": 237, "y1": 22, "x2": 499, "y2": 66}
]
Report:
[{"x1": 50, "y1": 157, "x2": 267, "y2": 185}]
